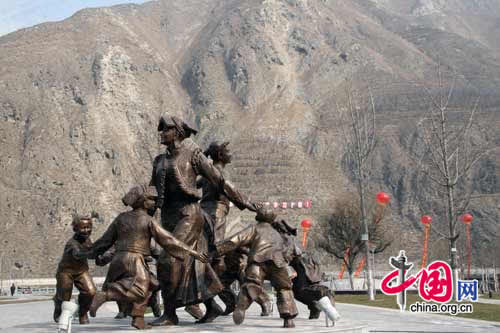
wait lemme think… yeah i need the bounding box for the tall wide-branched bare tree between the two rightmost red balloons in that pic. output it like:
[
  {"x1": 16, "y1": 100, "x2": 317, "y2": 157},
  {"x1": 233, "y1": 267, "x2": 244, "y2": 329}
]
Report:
[{"x1": 410, "y1": 65, "x2": 488, "y2": 296}]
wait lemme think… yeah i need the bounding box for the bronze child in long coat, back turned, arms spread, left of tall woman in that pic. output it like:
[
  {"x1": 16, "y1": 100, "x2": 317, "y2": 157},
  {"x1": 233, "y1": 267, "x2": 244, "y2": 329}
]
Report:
[{"x1": 90, "y1": 186, "x2": 208, "y2": 329}]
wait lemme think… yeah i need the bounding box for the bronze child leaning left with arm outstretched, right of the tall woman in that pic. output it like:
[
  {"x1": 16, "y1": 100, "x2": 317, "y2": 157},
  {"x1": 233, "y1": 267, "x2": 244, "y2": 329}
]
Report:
[{"x1": 215, "y1": 207, "x2": 298, "y2": 328}]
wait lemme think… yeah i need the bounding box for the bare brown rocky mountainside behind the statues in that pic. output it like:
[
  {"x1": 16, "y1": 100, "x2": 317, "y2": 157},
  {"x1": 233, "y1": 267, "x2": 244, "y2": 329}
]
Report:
[{"x1": 0, "y1": 0, "x2": 500, "y2": 276}]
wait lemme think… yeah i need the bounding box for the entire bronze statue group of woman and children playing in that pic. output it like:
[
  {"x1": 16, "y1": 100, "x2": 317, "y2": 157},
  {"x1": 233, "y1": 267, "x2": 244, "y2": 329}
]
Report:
[{"x1": 54, "y1": 115, "x2": 339, "y2": 329}]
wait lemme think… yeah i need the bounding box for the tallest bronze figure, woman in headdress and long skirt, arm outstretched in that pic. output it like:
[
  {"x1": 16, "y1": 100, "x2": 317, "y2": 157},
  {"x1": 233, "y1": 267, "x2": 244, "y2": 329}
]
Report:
[{"x1": 150, "y1": 115, "x2": 256, "y2": 326}]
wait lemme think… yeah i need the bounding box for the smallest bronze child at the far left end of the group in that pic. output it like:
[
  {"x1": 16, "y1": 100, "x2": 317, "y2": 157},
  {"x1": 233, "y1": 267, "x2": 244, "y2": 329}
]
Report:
[{"x1": 54, "y1": 216, "x2": 96, "y2": 325}]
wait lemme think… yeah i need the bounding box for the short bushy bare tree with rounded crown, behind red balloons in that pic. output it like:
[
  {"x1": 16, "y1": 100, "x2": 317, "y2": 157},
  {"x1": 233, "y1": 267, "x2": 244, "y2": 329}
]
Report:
[{"x1": 317, "y1": 193, "x2": 392, "y2": 289}]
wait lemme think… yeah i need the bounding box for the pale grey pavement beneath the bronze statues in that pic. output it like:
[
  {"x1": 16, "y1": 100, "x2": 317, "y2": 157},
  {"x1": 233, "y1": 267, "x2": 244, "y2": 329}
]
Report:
[{"x1": 0, "y1": 296, "x2": 500, "y2": 333}]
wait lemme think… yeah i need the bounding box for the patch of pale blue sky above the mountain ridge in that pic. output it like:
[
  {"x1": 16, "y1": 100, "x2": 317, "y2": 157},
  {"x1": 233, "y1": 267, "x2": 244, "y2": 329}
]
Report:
[{"x1": 0, "y1": 0, "x2": 146, "y2": 36}]
